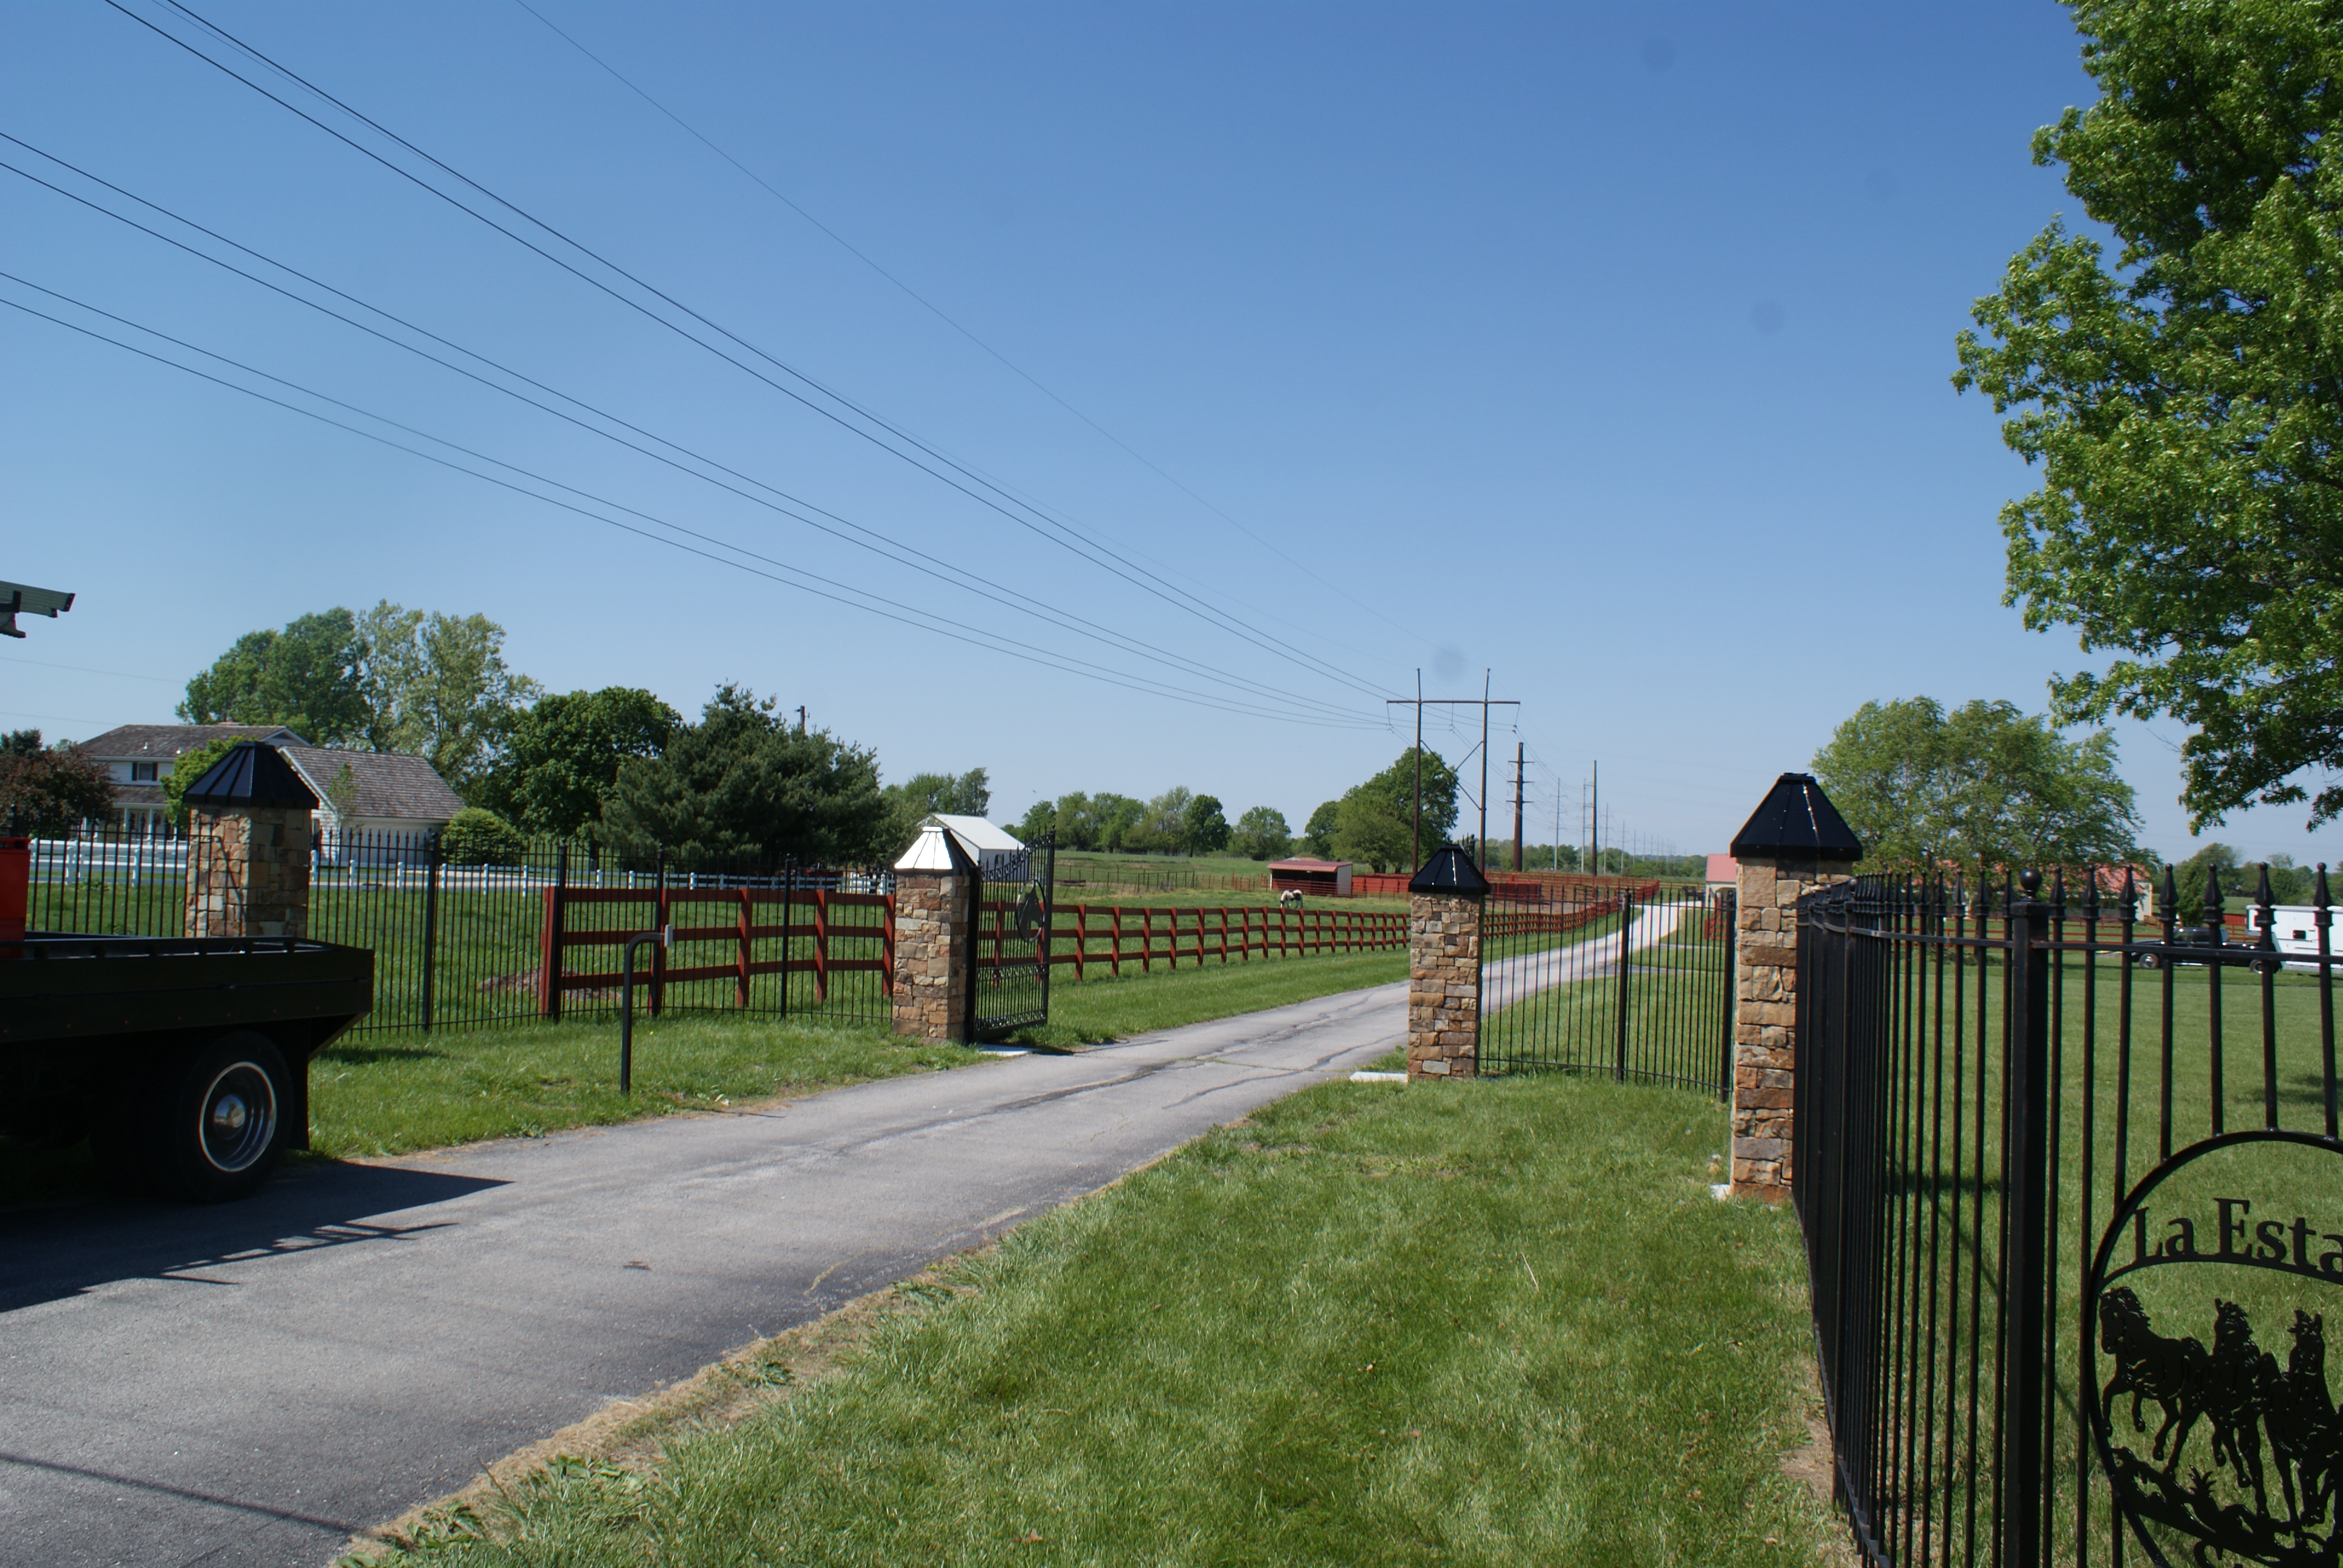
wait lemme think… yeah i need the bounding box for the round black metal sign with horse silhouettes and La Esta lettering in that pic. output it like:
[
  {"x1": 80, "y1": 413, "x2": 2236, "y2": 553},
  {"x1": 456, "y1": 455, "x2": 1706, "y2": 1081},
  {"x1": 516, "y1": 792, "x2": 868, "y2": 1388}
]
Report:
[{"x1": 2088, "y1": 1129, "x2": 2343, "y2": 1568}]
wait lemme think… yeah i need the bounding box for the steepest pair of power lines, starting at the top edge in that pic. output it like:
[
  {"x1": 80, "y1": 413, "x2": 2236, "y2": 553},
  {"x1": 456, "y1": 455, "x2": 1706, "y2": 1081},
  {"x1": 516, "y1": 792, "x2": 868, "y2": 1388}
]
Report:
[{"x1": 105, "y1": 0, "x2": 1380, "y2": 696}]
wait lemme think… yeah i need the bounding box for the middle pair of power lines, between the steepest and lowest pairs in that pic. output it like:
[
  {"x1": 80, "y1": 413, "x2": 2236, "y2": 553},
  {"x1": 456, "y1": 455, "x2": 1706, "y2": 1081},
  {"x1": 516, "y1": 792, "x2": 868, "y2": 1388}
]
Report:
[{"x1": 0, "y1": 131, "x2": 1362, "y2": 719}]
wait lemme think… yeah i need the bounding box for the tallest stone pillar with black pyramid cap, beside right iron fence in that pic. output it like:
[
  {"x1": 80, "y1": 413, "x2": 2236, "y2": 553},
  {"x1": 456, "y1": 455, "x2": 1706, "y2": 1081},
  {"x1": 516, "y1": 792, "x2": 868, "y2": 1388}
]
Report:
[{"x1": 1731, "y1": 774, "x2": 1863, "y2": 1203}]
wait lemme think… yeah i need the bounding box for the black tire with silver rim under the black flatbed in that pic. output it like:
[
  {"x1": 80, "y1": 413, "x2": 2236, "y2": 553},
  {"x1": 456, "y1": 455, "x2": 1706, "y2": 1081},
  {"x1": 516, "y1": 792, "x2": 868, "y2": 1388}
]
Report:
[{"x1": 148, "y1": 1029, "x2": 293, "y2": 1203}]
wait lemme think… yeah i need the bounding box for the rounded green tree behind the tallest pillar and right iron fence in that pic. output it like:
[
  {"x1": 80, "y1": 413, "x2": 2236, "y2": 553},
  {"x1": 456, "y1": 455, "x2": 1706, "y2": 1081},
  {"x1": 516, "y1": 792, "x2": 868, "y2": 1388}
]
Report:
[{"x1": 1814, "y1": 696, "x2": 2139, "y2": 872}]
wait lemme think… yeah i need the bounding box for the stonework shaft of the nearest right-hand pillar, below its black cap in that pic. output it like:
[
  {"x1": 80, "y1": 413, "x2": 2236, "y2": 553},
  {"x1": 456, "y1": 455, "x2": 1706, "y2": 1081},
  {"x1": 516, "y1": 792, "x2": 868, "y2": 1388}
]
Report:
[{"x1": 1731, "y1": 855, "x2": 1846, "y2": 1203}]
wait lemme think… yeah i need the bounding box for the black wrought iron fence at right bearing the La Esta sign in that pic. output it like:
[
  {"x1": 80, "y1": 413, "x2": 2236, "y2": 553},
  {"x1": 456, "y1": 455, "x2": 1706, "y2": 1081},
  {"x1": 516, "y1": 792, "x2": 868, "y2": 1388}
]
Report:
[{"x1": 1792, "y1": 867, "x2": 2343, "y2": 1568}]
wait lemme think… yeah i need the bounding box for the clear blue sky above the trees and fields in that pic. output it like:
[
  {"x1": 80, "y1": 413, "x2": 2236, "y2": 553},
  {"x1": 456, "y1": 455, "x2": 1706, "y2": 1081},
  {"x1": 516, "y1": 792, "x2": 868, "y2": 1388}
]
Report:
[{"x1": 0, "y1": 0, "x2": 2343, "y2": 858}]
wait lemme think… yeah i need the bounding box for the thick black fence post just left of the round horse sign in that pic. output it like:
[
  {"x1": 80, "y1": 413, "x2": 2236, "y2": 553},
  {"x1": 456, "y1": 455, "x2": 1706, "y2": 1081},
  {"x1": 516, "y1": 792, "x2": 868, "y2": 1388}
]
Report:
[{"x1": 1980, "y1": 872, "x2": 2050, "y2": 1568}]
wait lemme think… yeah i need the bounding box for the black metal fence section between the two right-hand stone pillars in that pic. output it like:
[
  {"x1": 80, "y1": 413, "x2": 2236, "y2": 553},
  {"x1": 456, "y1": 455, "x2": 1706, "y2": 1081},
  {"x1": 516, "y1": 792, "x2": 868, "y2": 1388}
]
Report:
[{"x1": 1481, "y1": 881, "x2": 1734, "y2": 1094}]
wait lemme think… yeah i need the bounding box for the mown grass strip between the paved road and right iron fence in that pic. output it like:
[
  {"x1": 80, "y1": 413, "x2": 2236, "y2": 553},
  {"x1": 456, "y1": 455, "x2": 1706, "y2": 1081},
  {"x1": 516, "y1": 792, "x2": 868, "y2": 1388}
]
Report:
[{"x1": 361, "y1": 1076, "x2": 1844, "y2": 1568}]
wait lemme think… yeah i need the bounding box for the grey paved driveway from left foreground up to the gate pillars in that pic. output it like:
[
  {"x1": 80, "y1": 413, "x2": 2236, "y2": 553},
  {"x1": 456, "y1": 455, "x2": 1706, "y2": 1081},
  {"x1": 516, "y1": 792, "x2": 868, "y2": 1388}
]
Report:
[{"x1": 0, "y1": 984, "x2": 1406, "y2": 1568}]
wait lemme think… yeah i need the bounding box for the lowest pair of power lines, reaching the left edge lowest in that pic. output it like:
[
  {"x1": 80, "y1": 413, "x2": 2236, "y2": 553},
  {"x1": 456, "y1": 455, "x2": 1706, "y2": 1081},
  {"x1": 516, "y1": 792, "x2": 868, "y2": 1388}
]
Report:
[{"x1": 0, "y1": 272, "x2": 1371, "y2": 729}]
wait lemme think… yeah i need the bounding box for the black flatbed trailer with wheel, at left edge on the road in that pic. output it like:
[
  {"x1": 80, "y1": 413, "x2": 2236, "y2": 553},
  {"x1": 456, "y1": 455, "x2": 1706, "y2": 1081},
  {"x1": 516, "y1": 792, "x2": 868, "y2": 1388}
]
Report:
[{"x1": 0, "y1": 930, "x2": 375, "y2": 1203}]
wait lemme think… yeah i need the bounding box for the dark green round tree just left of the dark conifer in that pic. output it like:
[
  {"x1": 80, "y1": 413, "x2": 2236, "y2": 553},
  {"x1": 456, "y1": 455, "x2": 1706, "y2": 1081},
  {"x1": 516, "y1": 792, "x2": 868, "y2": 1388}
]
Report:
[{"x1": 476, "y1": 687, "x2": 684, "y2": 837}]
